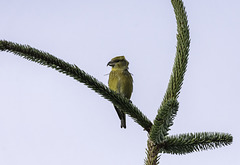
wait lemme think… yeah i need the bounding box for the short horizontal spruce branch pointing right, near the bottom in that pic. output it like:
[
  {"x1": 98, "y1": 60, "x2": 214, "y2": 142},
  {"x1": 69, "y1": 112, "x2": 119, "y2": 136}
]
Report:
[{"x1": 159, "y1": 132, "x2": 233, "y2": 155}]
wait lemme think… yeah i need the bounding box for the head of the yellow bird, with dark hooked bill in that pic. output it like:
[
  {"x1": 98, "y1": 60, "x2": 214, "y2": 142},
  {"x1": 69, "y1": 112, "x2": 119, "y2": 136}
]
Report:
[{"x1": 107, "y1": 56, "x2": 129, "y2": 69}]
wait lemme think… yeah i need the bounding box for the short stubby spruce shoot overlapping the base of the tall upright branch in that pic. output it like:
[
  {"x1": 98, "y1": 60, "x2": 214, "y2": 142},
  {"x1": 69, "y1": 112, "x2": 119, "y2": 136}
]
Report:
[{"x1": 150, "y1": 99, "x2": 179, "y2": 144}]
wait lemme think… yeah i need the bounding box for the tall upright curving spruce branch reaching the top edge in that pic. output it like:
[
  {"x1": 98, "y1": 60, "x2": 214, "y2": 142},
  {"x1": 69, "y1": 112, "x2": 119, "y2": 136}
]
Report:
[{"x1": 162, "y1": 0, "x2": 190, "y2": 105}]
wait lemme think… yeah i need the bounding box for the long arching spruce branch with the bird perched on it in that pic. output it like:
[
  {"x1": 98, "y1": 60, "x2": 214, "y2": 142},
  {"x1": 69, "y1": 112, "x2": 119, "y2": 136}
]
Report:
[{"x1": 0, "y1": 40, "x2": 152, "y2": 132}]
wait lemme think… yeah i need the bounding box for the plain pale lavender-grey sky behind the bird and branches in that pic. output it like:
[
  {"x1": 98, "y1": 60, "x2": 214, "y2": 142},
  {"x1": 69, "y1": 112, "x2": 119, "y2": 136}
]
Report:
[{"x1": 0, "y1": 0, "x2": 240, "y2": 165}]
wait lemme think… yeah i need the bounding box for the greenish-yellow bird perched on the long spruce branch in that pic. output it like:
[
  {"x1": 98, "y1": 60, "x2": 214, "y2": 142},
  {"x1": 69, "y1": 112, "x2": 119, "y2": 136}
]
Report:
[{"x1": 107, "y1": 56, "x2": 133, "y2": 128}]
